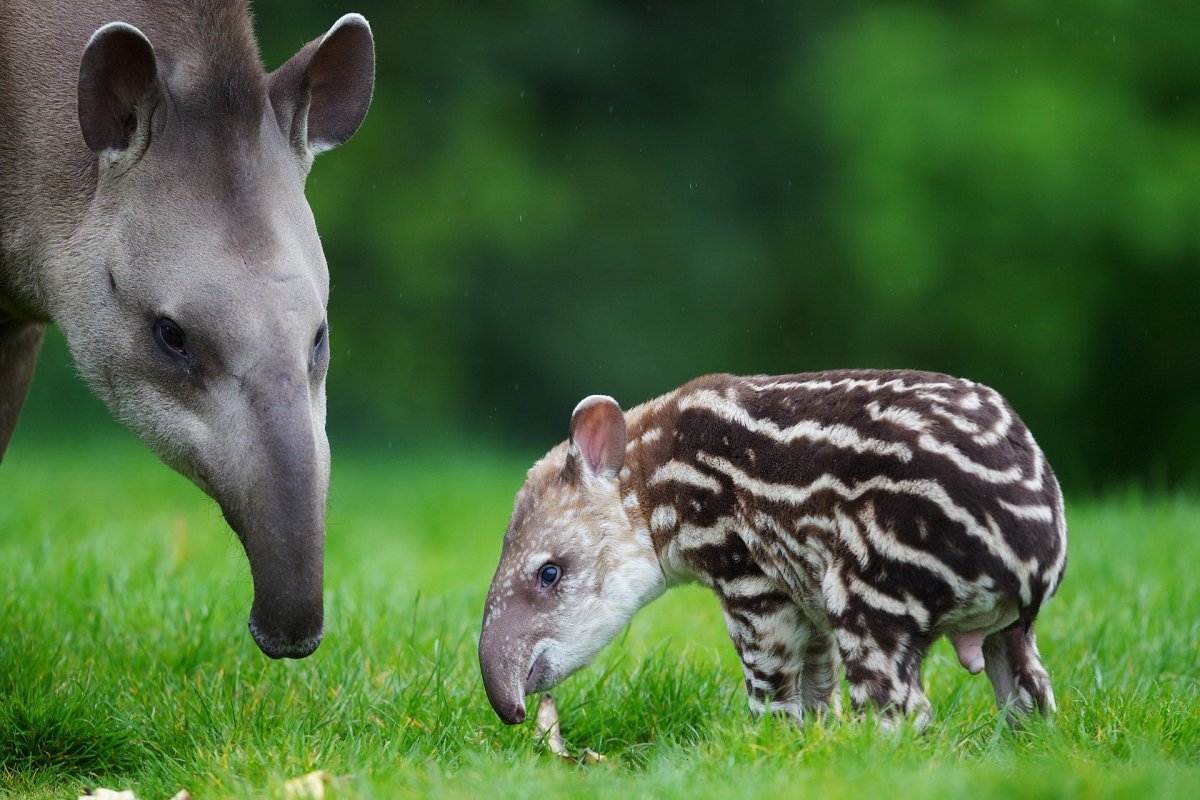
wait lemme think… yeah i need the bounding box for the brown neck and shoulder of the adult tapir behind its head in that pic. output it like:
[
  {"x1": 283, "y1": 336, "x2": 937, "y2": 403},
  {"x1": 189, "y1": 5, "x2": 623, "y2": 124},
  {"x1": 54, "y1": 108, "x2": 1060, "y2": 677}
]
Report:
[{"x1": 0, "y1": 0, "x2": 268, "y2": 321}]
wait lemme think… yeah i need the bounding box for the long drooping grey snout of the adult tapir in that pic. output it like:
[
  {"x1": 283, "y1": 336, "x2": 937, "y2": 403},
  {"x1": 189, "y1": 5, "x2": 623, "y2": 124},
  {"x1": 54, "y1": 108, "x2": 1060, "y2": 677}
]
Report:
[{"x1": 217, "y1": 372, "x2": 329, "y2": 658}]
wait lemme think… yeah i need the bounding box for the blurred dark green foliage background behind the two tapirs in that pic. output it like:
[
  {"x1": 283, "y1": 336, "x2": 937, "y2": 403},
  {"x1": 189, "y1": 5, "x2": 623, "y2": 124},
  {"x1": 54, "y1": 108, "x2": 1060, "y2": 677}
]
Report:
[{"x1": 17, "y1": 0, "x2": 1200, "y2": 491}]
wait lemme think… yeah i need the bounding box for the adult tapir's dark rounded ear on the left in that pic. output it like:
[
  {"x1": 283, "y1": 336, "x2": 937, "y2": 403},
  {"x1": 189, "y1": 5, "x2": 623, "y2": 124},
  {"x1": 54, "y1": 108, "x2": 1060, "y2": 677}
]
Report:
[{"x1": 78, "y1": 23, "x2": 158, "y2": 154}]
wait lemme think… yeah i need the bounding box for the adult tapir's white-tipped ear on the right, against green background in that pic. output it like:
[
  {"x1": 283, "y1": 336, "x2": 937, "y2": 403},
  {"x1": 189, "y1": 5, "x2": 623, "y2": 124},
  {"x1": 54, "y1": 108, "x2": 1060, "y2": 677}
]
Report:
[{"x1": 269, "y1": 14, "x2": 374, "y2": 161}]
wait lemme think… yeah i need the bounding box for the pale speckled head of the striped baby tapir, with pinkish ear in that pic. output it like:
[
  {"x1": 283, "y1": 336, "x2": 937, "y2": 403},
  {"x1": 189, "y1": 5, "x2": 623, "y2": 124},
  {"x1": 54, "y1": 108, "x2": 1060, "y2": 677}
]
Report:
[{"x1": 479, "y1": 395, "x2": 666, "y2": 724}]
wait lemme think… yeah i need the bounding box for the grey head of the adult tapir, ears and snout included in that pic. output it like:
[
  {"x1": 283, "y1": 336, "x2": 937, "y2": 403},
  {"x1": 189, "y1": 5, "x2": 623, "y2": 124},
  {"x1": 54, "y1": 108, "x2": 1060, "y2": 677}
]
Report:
[{"x1": 55, "y1": 14, "x2": 374, "y2": 658}]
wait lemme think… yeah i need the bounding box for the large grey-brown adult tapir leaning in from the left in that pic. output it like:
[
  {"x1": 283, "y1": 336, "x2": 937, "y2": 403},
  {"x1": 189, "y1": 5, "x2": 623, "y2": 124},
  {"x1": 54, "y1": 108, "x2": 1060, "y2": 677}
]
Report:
[{"x1": 0, "y1": 0, "x2": 374, "y2": 658}]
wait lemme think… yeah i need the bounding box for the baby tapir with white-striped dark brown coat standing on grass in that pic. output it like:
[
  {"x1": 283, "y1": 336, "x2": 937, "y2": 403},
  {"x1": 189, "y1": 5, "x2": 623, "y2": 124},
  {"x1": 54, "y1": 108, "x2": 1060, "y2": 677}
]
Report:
[{"x1": 479, "y1": 371, "x2": 1067, "y2": 726}]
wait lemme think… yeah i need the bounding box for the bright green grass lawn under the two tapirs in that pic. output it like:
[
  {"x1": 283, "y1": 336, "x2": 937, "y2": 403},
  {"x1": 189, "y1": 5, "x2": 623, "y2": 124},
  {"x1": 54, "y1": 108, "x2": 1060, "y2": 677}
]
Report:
[{"x1": 0, "y1": 437, "x2": 1200, "y2": 800}]
